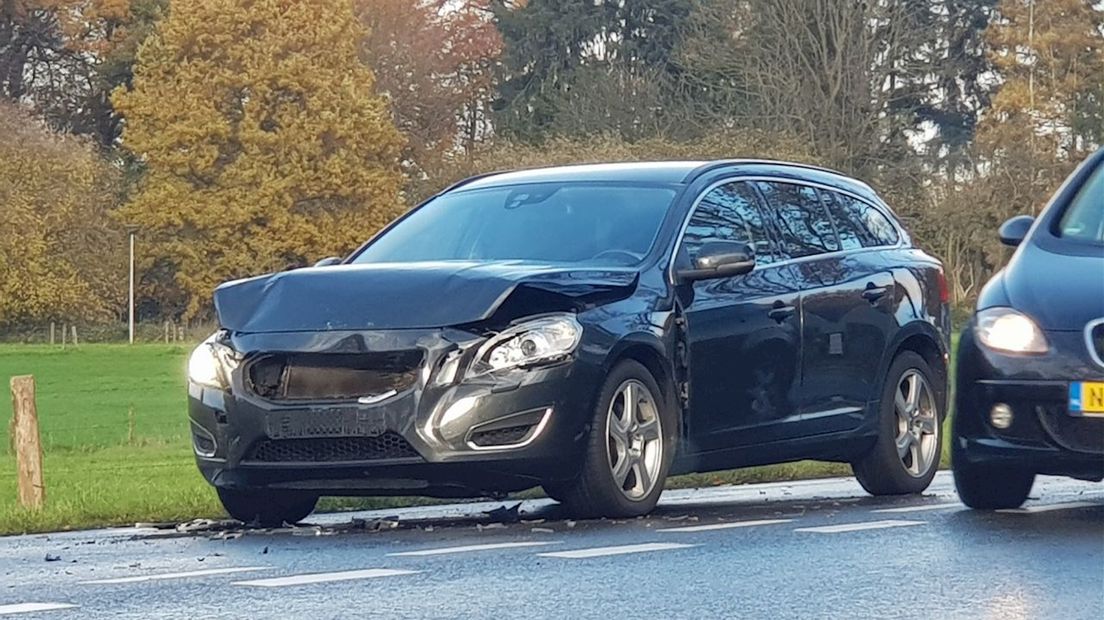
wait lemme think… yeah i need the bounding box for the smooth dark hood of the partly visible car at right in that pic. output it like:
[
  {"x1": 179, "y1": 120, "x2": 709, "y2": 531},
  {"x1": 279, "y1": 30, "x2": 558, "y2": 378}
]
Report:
[{"x1": 1001, "y1": 241, "x2": 1104, "y2": 330}]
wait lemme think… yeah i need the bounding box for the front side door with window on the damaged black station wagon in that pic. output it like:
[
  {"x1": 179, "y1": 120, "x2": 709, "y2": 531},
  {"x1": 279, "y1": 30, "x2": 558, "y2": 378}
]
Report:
[{"x1": 676, "y1": 182, "x2": 800, "y2": 452}]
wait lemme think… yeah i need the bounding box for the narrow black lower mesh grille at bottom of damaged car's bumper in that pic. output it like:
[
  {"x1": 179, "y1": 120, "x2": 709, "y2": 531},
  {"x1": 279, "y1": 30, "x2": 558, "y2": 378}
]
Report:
[{"x1": 246, "y1": 431, "x2": 420, "y2": 463}]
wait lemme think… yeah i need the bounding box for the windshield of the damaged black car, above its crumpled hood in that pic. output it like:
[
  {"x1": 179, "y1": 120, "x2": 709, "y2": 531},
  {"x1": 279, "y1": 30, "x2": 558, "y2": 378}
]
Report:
[{"x1": 353, "y1": 183, "x2": 676, "y2": 266}]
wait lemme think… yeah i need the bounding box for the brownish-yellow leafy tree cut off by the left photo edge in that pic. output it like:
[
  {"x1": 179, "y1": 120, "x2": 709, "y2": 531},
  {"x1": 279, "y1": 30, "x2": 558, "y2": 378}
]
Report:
[{"x1": 0, "y1": 101, "x2": 126, "y2": 327}]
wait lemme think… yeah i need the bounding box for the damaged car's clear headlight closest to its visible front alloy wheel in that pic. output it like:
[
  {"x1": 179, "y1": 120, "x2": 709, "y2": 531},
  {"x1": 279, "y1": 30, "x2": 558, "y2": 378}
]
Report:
[{"x1": 468, "y1": 314, "x2": 583, "y2": 375}]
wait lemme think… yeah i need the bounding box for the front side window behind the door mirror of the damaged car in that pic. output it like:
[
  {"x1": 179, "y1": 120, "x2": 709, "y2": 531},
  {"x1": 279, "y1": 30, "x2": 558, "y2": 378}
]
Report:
[{"x1": 682, "y1": 182, "x2": 775, "y2": 265}]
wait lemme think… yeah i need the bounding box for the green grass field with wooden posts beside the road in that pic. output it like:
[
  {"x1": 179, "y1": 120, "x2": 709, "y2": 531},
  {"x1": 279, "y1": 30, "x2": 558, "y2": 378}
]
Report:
[{"x1": 0, "y1": 344, "x2": 948, "y2": 534}]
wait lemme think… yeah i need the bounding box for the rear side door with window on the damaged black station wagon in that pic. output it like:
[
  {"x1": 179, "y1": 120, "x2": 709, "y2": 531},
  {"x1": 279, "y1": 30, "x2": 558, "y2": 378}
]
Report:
[{"x1": 757, "y1": 181, "x2": 895, "y2": 436}]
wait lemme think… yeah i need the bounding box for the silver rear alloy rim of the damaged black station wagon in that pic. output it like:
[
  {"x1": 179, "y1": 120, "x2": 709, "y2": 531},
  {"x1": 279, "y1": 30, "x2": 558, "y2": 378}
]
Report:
[{"x1": 893, "y1": 368, "x2": 941, "y2": 478}]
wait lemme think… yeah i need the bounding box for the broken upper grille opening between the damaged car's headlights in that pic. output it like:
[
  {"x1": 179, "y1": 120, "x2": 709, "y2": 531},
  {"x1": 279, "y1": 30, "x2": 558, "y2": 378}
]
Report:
[{"x1": 245, "y1": 351, "x2": 423, "y2": 402}]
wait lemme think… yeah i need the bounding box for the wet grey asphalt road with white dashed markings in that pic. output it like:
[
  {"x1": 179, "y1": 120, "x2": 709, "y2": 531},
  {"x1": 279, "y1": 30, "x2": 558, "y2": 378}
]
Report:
[{"x1": 0, "y1": 473, "x2": 1104, "y2": 620}]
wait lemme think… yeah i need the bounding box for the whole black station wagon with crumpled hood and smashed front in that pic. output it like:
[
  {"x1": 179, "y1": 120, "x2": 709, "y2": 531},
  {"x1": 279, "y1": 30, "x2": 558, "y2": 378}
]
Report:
[{"x1": 189, "y1": 160, "x2": 949, "y2": 524}]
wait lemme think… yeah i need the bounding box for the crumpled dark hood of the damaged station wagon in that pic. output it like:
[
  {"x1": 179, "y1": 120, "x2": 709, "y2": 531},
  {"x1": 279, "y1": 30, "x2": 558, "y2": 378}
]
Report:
[{"x1": 214, "y1": 261, "x2": 637, "y2": 333}]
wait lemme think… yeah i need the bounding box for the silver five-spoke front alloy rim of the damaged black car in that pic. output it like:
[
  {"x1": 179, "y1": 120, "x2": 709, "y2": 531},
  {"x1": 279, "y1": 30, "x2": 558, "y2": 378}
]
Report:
[{"x1": 606, "y1": 380, "x2": 664, "y2": 501}]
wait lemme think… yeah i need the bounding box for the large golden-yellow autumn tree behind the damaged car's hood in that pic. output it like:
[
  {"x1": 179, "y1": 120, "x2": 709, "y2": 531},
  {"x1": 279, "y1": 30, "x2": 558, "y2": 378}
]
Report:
[{"x1": 113, "y1": 0, "x2": 403, "y2": 317}]
